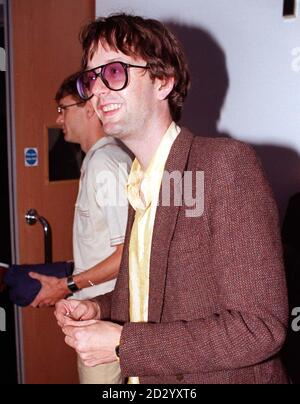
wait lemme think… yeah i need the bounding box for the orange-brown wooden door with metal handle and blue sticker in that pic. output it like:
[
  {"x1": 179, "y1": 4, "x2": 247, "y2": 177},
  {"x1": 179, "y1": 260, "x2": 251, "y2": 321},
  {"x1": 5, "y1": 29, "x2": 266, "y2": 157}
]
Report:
[{"x1": 9, "y1": 0, "x2": 95, "y2": 384}]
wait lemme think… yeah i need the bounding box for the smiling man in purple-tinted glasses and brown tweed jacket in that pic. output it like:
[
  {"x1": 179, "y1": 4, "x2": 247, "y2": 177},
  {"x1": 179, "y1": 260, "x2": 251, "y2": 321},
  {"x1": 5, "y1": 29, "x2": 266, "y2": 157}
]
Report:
[{"x1": 56, "y1": 14, "x2": 288, "y2": 384}]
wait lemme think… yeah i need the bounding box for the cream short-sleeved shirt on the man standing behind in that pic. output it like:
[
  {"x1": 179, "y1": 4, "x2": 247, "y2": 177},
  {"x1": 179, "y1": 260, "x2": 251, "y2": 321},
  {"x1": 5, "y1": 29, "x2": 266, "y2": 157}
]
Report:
[{"x1": 72, "y1": 136, "x2": 132, "y2": 300}]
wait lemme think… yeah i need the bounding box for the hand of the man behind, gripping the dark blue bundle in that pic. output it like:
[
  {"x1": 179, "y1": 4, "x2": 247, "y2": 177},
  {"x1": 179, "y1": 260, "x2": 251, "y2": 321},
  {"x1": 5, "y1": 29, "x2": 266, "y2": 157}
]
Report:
[{"x1": 29, "y1": 272, "x2": 70, "y2": 307}]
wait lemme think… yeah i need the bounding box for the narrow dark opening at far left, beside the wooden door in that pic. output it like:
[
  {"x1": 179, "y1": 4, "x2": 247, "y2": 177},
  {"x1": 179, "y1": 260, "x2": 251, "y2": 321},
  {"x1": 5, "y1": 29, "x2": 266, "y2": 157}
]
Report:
[{"x1": 0, "y1": 0, "x2": 17, "y2": 384}]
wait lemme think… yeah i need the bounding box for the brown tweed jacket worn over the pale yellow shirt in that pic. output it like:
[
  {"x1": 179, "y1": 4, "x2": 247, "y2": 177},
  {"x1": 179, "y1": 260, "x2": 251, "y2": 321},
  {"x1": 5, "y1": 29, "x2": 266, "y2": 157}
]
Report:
[{"x1": 98, "y1": 129, "x2": 287, "y2": 384}]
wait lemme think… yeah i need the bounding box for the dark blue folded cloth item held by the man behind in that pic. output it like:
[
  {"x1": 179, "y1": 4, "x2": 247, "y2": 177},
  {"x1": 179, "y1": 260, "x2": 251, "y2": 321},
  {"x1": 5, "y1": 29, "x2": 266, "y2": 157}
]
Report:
[{"x1": 4, "y1": 261, "x2": 74, "y2": 307}]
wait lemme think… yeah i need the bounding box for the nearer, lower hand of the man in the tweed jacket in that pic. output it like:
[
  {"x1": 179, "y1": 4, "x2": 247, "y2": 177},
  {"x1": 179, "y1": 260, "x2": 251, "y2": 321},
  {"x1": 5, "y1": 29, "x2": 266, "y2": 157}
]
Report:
[{"x1": 62, "y1": 320, "x2": 123, "y2": 367}]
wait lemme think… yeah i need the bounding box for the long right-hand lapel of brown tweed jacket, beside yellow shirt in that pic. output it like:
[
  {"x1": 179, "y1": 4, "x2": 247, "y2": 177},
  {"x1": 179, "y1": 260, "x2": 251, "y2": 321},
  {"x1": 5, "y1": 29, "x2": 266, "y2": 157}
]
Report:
[{"x1": 148, "y1": 129, "x2": 194, "y2": 323}]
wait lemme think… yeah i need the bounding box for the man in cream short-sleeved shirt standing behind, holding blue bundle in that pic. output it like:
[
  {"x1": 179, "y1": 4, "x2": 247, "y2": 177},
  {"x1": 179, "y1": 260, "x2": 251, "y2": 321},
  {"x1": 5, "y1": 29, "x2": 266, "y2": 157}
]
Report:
[{"x1": 30, "y1": 74, "x2": 131, "y2": 384}]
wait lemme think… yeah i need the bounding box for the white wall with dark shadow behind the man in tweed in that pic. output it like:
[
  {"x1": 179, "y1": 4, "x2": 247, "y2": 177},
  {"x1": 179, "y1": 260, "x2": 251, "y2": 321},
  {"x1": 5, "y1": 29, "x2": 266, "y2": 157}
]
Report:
[{"x1": 96, "y1": 0, "x2": 300, "y2": 219}]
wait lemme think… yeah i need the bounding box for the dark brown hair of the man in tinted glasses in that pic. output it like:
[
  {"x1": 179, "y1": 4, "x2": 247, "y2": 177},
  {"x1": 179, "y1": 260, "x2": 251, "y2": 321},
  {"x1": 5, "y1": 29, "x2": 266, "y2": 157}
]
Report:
[{"x1": 80, "y1": 14, "x2": 190, "y2": 122}]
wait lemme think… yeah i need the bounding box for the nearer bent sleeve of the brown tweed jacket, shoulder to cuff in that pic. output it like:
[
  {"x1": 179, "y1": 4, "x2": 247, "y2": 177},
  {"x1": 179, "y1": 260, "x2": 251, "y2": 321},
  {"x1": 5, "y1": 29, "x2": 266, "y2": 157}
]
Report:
[{"x1": 120, "y1": 142, "x2": 288, "y2": 376}]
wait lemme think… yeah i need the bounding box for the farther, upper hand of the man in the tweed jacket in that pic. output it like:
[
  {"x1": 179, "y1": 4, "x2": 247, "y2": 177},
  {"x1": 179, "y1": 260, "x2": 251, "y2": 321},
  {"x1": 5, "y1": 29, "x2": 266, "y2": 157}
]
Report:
[{"x1": 54, "y1": 299, "x2": 100, "y2": 327}]
